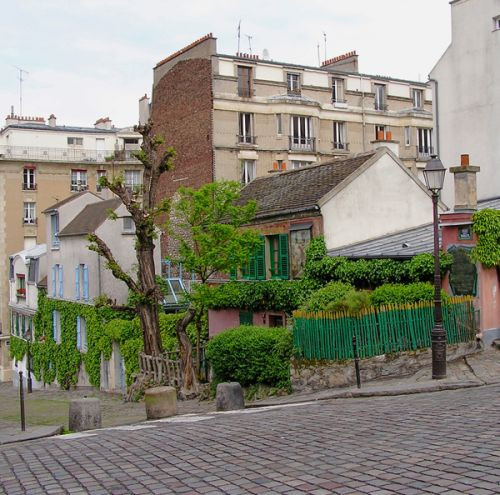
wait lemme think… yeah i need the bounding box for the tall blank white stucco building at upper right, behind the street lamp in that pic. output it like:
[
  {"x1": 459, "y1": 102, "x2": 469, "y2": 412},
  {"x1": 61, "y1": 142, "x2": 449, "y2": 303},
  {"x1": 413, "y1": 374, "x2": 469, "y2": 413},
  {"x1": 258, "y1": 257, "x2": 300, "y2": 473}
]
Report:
[{"x1": 430, "y1": 0, "x2": 500, "y2": 204}]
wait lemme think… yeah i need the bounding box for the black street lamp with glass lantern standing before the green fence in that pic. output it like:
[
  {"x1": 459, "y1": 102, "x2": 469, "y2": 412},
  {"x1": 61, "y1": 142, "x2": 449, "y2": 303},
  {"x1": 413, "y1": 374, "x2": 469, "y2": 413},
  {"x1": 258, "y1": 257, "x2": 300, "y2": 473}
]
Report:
[{"x1": 424, "y1": 155, "x2": 446, "y2": 380}]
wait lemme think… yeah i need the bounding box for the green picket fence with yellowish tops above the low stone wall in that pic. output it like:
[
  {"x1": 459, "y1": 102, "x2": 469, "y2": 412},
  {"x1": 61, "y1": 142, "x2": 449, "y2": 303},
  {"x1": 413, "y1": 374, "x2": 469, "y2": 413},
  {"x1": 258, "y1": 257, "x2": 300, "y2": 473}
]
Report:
[{"x1": 293, "y1": 297, "x2": 476, "y2": 361}]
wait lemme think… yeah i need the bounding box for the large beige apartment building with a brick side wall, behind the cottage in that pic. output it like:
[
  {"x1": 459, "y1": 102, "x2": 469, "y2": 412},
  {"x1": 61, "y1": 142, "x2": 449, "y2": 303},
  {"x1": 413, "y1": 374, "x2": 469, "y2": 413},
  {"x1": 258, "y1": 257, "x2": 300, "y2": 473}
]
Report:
[{"x1": 148, "y1": 34, "x2": 433, "y2": 204}]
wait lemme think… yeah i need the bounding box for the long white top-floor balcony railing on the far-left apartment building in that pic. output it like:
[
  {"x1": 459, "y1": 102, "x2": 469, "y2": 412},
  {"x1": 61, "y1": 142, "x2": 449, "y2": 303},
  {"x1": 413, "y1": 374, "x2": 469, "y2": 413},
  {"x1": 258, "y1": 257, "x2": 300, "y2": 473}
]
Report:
[{"x1": 0, "y1": 145, "x2": 141, "y2": 163}]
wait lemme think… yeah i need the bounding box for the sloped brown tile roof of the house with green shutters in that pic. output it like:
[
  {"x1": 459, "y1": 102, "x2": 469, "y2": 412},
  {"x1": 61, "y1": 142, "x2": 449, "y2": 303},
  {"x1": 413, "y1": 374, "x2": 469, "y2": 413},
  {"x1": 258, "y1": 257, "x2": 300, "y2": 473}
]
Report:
[{"x1": 240, "y1": 151, "x2": 376, "y2": 219}]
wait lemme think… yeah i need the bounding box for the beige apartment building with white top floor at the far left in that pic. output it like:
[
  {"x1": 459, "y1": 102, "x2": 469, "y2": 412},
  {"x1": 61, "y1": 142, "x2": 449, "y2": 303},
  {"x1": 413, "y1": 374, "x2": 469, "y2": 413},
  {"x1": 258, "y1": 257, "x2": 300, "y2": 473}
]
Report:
[{"x1": 0, "y1": 112, "x2": 142, "y2": 381}]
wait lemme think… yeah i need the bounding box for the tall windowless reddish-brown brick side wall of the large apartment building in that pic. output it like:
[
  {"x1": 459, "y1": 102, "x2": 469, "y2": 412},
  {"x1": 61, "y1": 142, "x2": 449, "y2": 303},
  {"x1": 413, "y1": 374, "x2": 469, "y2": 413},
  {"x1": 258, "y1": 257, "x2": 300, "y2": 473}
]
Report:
[{"x1": 152, "y1": 59, "x2": 214, "y2": 256}]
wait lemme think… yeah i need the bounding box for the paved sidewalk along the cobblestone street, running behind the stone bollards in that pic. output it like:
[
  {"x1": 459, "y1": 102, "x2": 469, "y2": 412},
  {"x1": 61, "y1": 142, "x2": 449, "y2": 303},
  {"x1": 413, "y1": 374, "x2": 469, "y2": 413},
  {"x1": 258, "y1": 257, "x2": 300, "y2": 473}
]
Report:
[{"x1": 0, "y1": 349, "x2": 500, "y2": 445}]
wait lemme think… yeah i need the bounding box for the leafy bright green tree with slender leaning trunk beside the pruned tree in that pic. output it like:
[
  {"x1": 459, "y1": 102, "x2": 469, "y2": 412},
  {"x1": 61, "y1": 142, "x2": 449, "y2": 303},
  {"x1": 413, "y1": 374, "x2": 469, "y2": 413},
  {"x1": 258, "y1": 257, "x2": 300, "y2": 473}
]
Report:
[{"x1": 171, "y1": 181, "x2": 261, "y2": 393}]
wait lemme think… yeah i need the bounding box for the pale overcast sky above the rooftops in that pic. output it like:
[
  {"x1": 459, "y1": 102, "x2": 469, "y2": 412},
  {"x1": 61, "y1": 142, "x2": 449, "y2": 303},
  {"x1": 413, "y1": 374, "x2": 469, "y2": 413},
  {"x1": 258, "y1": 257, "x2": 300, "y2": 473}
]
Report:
[{"x1": 0, "y1": 0, "x2": 451, "y2": 126}]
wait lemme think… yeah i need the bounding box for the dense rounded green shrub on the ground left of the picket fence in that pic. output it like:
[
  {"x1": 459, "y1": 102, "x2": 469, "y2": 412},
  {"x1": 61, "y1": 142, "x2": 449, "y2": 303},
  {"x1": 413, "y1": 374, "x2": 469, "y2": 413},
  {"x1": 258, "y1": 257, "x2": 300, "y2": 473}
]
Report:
[{"x1": 206, "y1": 326, "x2": 293, "y2": 388}]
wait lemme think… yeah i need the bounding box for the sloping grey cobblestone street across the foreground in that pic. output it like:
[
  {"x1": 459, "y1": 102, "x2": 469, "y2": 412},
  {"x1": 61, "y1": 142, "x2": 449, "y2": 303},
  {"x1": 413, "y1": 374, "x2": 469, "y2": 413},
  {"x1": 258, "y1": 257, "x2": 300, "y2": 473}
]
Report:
[{"x1": 0, "y1": 385, "x2": 500, "y2": 495}]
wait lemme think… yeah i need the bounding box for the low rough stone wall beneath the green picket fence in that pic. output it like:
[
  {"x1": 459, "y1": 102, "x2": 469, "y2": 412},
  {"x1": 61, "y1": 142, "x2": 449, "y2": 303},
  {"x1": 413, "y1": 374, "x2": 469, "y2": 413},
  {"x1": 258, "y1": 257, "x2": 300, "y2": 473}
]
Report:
[{"x1": 290, "y1": 342, "x2": 476, "y2": 392}]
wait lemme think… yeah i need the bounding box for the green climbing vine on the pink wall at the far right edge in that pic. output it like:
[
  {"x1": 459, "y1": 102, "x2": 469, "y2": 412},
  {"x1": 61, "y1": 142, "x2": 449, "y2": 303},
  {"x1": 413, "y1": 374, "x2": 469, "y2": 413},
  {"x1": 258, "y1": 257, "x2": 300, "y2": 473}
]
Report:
[{"x1": 471, "y1": 209, "x2": 500, "y2": 268}]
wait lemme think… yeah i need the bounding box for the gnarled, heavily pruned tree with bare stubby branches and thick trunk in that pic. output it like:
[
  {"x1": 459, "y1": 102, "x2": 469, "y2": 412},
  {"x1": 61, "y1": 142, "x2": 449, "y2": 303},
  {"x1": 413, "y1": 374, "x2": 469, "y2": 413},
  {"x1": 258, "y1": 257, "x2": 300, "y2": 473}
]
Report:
[{"x1": 88, "y1": 121, "x2": 175, "y2": 356}]
